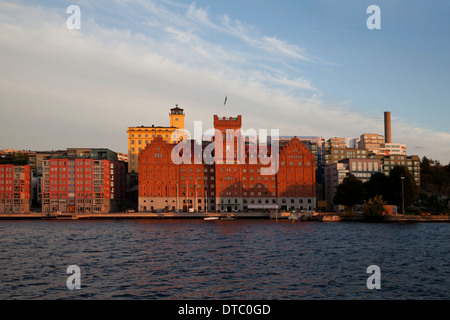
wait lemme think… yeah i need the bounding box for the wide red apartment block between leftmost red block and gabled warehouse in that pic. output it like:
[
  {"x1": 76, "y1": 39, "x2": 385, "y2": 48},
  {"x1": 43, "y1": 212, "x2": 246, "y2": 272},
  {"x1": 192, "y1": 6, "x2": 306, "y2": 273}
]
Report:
[{"x1": 42, "y1": 158, "x2": 125, "y2": 213}]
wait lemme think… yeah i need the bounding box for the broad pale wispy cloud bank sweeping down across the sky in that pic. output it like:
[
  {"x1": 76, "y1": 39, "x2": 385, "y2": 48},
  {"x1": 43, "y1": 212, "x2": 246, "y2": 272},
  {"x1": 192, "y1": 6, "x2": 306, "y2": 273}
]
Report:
[{"x1": 0, "y1": 0, "x2": 450, "y2": 161}]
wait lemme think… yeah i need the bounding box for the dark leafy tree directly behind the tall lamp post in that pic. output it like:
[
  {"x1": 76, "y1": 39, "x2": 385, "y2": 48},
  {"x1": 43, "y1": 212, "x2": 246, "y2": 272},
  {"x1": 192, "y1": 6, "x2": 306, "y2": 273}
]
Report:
[{"x1": 387, "y1": 166, "x2": 420, "y2": 209}]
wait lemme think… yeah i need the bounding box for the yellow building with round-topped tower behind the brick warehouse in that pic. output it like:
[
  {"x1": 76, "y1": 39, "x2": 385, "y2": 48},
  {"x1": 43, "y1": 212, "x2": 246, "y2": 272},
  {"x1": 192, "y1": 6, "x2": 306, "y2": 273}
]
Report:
[{"x1": 127, "y1": 105, "x2": 187, "y2": 173}]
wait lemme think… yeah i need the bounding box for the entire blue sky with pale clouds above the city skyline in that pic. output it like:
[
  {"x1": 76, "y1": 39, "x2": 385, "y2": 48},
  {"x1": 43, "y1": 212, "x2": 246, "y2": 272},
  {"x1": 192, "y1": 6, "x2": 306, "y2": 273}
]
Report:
[{"x1": 0, "y1": 0, "x2": 450, "y2": 164}]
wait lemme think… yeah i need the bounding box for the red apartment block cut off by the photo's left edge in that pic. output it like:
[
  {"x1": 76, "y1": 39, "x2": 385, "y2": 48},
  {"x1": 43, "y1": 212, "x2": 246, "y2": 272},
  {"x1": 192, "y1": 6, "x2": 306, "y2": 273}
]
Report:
[{"x1": 0, "y1": 164, "x2": 31, "y2": 213}]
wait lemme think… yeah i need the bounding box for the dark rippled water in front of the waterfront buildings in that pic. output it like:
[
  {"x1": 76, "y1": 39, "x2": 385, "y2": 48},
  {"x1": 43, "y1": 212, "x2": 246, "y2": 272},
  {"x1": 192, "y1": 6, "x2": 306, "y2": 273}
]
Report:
[{"x1": 0, "y1": 220, "x2": 450, "y2": 300}]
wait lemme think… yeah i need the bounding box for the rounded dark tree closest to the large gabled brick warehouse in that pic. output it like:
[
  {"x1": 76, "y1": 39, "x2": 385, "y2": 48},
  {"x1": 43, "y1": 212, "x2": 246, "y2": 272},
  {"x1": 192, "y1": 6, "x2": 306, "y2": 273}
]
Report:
[{"x1": 333, "y1": 174, "x2": 365, "y2": 211}]
